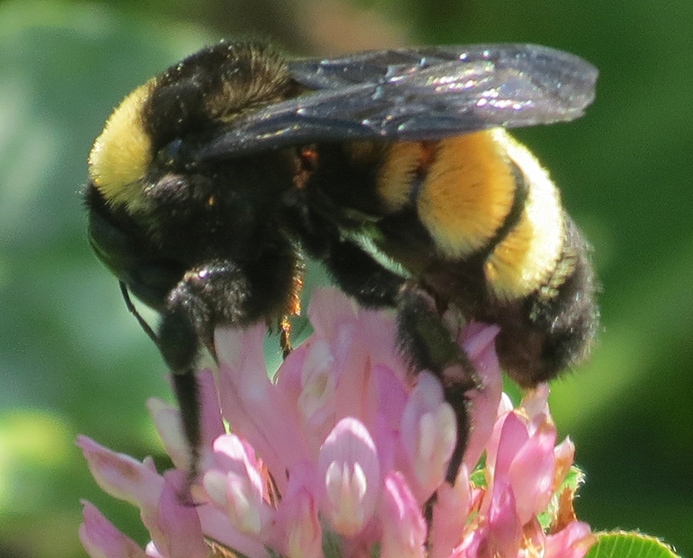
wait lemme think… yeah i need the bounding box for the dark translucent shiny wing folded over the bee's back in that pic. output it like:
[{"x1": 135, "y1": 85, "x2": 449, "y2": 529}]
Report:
[{"x1": 199, "y1": 44, "x2": 597, "y2": 158}]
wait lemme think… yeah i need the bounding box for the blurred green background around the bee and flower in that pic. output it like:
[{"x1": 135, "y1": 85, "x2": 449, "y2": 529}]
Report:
[{"x1": 0, "y1": 0, "x2": 693, "y2": 558}]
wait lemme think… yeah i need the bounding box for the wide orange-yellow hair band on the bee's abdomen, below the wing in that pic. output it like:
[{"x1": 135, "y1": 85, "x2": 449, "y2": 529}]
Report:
[{"x1": 418, "y1": 131, "x2": 516, "y2": 259}]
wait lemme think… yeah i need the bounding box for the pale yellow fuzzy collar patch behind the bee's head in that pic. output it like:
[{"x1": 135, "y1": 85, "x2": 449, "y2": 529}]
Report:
[{"x1": 89, "y1": 81, "x2": 152, "y2": 206}]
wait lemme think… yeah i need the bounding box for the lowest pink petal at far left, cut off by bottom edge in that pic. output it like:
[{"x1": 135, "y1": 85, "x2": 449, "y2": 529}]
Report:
[{"x1": 79, "y1": 501, "x2": 145, "y2": 558}]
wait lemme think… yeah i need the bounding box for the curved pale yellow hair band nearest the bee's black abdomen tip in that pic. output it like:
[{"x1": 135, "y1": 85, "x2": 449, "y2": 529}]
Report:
[{"x1": 484, "y1": 134, "x2": 565, "y2": 300}]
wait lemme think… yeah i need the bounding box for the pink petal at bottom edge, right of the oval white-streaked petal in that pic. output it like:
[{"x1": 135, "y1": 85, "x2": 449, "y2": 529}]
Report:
[{"x1": 379, "y1": 472, "x2": 426, "y2": 558}]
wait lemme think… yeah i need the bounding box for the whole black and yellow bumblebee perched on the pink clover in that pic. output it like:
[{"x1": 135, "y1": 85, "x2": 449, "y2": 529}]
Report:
[{"x1": 84, "y1": 41, "x2": 598, "y2": 481}]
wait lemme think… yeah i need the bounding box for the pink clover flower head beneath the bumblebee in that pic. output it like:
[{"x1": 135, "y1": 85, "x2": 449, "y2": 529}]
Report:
[{"x1": 79, "y1": 290, "x2": 592, "y2": 558}]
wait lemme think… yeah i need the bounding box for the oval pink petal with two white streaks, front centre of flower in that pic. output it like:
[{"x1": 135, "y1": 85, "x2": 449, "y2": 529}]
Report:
[{"x1": 318, "y1": 418, "x2": 380, "y2": 536}]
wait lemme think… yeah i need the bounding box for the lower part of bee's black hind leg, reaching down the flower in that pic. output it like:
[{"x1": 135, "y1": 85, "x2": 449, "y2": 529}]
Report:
[{"x1": 397, "y1": 282, "x2": 479, "y2": 484}]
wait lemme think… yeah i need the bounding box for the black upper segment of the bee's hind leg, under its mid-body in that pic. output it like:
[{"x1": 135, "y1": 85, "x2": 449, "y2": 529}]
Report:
[{"x1": 323, "y1": 239, "x2": 405, "y2": 308}]
